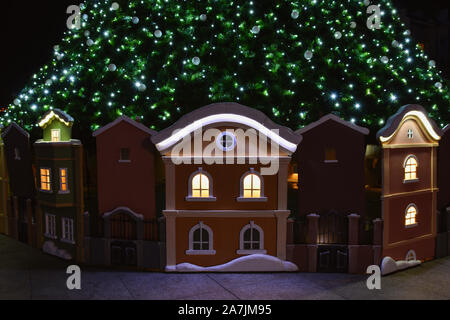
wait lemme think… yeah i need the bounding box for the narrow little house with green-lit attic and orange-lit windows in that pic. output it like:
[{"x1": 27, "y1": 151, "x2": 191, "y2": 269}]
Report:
[{"x1": 34, "y1": 109, "x2": 84, "y2": 261}]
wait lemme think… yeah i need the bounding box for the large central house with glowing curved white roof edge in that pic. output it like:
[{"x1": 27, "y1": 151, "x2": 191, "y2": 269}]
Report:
[{"x1": 152, "y1": 103, "x2": 301, "y2": 271}]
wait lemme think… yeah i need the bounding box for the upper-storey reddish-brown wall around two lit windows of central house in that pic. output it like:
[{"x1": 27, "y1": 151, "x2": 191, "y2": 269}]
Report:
[{"x1": 175, "y1": 164, "x2": 276, "y2": 210}]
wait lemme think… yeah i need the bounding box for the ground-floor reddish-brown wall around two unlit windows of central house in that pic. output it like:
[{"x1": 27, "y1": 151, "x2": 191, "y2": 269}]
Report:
[{"x1": 176, "y1": 216, "x2": 277, "y2": 267}]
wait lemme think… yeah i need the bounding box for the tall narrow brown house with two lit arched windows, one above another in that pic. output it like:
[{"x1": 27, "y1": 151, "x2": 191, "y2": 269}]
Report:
[{"x1": 377, "y1": 105, "x2": 442, "y2": 274}]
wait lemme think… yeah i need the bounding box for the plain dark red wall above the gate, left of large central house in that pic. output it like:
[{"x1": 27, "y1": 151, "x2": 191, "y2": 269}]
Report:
[{"x1": 96, "y1": 121, "x2": 156, "y2": 218}]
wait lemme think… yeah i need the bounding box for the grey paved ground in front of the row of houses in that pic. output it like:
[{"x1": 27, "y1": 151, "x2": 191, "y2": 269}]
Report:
[{"x1": 0, "y1": 236, "x2": 450, "y2": 300}]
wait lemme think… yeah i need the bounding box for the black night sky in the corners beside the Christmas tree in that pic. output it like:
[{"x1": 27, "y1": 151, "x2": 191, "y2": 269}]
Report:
[{"x1": 0, "y1": 0, "x2": 450, "y2": 109}]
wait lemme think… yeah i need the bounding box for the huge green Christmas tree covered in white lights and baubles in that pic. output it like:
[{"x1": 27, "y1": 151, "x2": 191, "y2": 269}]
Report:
[{"x1": 0, "y1": 0, "x2": 450, "y2": 140}]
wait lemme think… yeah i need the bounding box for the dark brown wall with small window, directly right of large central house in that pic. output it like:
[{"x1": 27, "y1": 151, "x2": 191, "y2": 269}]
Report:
[{"x1": 296, "y1": 121, "x2": 365, "y2": 217}]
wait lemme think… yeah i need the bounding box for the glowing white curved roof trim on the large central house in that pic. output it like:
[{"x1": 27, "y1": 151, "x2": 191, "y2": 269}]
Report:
[{"x1": 156, "y1": 113, "x2": 297, "y2": 153}]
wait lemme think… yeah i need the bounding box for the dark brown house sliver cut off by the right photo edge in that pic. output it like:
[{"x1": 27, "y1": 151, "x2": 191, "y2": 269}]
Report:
[{"x1": 437, "y1": 125, "x2": 450, "y2": 213}]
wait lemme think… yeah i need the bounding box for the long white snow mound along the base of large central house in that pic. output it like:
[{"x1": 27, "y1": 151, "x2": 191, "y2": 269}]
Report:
[{"x1": 166, "y1": 254, "x2": 298, "y2": 272}]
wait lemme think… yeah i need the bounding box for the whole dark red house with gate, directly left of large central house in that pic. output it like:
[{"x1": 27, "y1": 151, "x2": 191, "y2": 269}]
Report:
[{"x1": 89, "y1": 116, "x2": 161, "y2": 269}]
